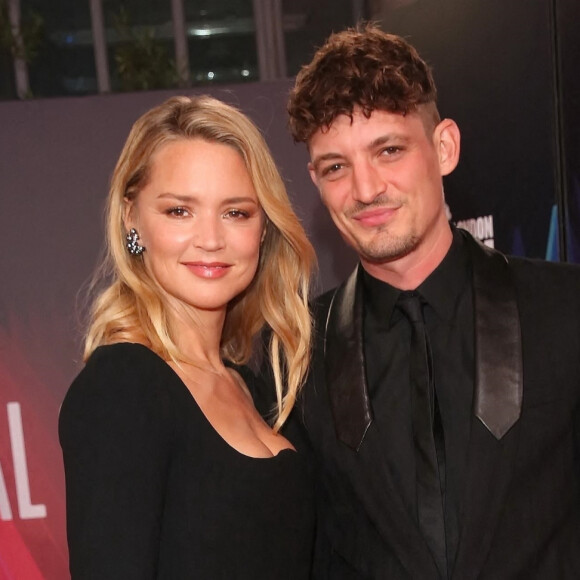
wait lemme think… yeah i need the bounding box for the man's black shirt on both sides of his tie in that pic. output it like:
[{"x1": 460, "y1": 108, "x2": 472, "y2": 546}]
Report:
[{"x1": 363, "y1": 232, "x2": 475, "y2": 572}]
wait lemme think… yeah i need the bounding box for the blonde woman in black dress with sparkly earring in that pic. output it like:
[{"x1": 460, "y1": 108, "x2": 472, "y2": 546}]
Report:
[{"x1": 59, "y1": 97, "x2": 314, "y2": 580}]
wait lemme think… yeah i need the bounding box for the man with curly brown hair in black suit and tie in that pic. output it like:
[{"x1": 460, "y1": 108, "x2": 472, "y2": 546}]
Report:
[{"x1": 289, "y1": 26, "x2": 580, "y2": 580}]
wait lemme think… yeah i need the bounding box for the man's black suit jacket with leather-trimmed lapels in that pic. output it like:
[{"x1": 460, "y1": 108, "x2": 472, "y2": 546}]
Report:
[{"x1": 290, "y1": 233, "x2": 580, "y2": 580}]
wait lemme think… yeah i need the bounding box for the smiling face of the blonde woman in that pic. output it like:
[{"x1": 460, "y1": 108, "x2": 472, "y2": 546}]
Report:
[{"x1": 125, "y1": 139, "x2": 264, "y2": 310}]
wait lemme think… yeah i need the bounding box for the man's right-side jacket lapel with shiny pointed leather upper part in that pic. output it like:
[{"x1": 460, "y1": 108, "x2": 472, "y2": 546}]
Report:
[{"x1": 453, "y1": 234, "x2": 523, "y2": 580}]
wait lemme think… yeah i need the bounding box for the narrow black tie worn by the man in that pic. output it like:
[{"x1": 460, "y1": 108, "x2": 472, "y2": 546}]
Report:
[{"x1": 398, "y1": 292, "x2": 447, "y2": 578}]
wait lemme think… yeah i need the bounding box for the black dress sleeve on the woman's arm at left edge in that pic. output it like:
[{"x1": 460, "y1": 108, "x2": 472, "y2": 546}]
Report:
[{"x1": 59, "y1": 345, "x2": 175, "y2": 580}]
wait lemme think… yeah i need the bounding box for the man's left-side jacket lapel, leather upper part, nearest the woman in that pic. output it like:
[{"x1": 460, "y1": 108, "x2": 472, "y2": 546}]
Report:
[{"x1": 324, "y1": 266, "x2": 438, "y2": 579}]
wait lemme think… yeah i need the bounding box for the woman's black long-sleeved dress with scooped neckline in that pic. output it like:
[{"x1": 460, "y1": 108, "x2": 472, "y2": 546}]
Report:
[{"x1": 59, "y1": 343, "x2": 314, "y2": 580}]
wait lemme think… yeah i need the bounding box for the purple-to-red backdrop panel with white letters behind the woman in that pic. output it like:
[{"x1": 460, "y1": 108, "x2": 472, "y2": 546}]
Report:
[{"x1": 0, "y1": 82, "x2": 354, "y2": 580}]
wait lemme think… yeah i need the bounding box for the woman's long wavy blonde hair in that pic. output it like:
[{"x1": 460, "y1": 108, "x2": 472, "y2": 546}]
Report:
[{"x1": 84, "y1": 96, "x2": 315, "y2": 430}]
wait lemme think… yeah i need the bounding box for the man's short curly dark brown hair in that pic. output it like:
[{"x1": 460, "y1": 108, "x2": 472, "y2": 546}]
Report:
[{"x1": 288, "y1": 24, "x2": 439, "y2": 142}]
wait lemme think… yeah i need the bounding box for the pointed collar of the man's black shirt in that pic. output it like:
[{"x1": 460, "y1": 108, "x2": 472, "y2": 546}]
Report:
[{"x1": 362, "y1": 228, "x2": 471, "y2": 320}]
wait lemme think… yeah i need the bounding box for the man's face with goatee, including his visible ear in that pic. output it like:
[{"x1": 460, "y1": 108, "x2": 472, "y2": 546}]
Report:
[{"x1": 309, "y1": 110, "x2": 459, "y2": 274}]
